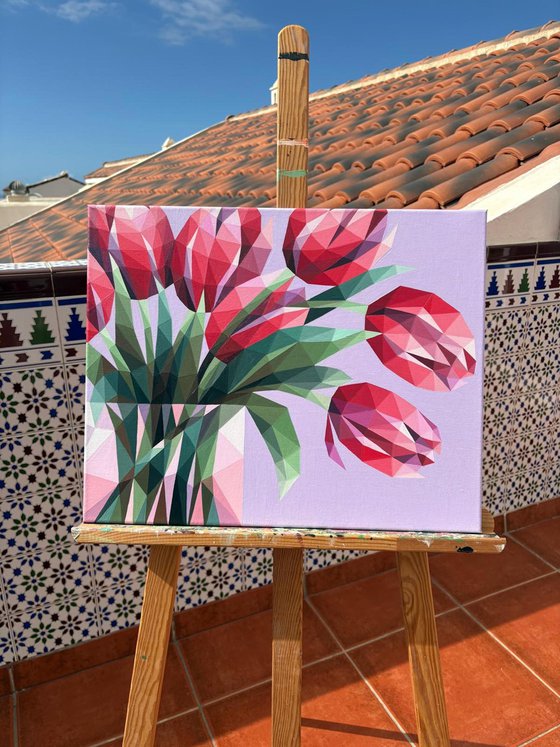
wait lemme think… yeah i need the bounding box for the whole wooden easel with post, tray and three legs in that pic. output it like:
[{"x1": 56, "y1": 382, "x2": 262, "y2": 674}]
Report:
[{"x1": 73, "y1": 26, "x2": 505, "y2": 747}]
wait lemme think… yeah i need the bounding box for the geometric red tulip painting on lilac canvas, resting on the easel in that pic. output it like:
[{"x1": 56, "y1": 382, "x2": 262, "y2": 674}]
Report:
[{"x1": 84, "y1": 206, "x2": 486, "y2": 532}]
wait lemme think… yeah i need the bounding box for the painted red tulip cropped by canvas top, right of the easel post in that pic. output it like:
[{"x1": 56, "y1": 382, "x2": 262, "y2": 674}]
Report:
[{"x1": 283, "y1": 210, "x2": 391, "y2": 285}]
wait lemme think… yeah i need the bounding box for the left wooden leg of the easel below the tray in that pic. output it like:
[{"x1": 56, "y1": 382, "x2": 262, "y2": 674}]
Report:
[{"x1": 123, "y1": 545, "x2": 181, "y2": 747}]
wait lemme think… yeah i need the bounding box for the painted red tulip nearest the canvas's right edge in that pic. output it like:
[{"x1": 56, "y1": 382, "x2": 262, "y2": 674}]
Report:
[{"x1": 365, "y1": 286, "x2": 476, "y2": 391}]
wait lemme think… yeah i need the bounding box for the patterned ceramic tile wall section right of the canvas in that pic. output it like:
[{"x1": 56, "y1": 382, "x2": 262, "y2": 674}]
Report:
[{"x1": 484, "y1": 242, "x2": 560, "y2": 513}]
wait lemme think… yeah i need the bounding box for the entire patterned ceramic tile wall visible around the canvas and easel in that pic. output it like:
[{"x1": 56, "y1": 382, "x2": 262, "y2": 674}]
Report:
[{"x1": 0, "y1": 250, "x2": 560, "y2": 663}]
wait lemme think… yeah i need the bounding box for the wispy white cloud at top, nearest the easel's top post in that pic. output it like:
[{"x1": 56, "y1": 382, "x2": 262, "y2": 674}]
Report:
[{"x1": 150, "y1": 0, "x2": 264, "y2": 45}]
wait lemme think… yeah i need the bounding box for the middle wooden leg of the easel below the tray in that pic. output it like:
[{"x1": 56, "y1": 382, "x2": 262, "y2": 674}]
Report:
[{"x1": 272, "y1": 548, "x2": 303, "y2": 747}]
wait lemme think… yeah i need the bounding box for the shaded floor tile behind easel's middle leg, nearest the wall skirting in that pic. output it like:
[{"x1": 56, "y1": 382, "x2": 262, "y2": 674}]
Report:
[{"x1": 182, "y1": 605, "x2": 336, "y2": 703}]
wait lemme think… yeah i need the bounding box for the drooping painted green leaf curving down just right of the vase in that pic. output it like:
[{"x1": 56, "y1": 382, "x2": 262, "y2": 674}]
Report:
[{"x1": 246, "y1": 394, "x2": 300, "y2": 497}]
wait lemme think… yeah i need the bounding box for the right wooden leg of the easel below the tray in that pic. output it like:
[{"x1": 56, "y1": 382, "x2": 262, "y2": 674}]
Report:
[{"x1": 397, "y1": 552, "x2": 449, "y2": 747}]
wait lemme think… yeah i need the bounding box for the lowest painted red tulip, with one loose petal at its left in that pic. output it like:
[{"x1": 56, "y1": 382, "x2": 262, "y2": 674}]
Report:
[{"x1": 325, "y1": 383, "x2": 441, "y2": 477}]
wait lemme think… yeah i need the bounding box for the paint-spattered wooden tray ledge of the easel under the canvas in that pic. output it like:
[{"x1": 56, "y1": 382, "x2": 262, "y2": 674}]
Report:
[{"x1": 72, "y1": 512, "x2": 505, "y2": 553}]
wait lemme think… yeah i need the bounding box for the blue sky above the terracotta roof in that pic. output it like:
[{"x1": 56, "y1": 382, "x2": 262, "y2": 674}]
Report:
[{"x1": 0, "y1": 0, "x2": 560, "y2": 187}]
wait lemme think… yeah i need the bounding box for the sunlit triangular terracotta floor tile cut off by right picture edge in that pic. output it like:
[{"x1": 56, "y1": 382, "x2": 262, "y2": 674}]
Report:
[{"x1": 469, "y1": 574, "x2": 560, "y2": 689}]
